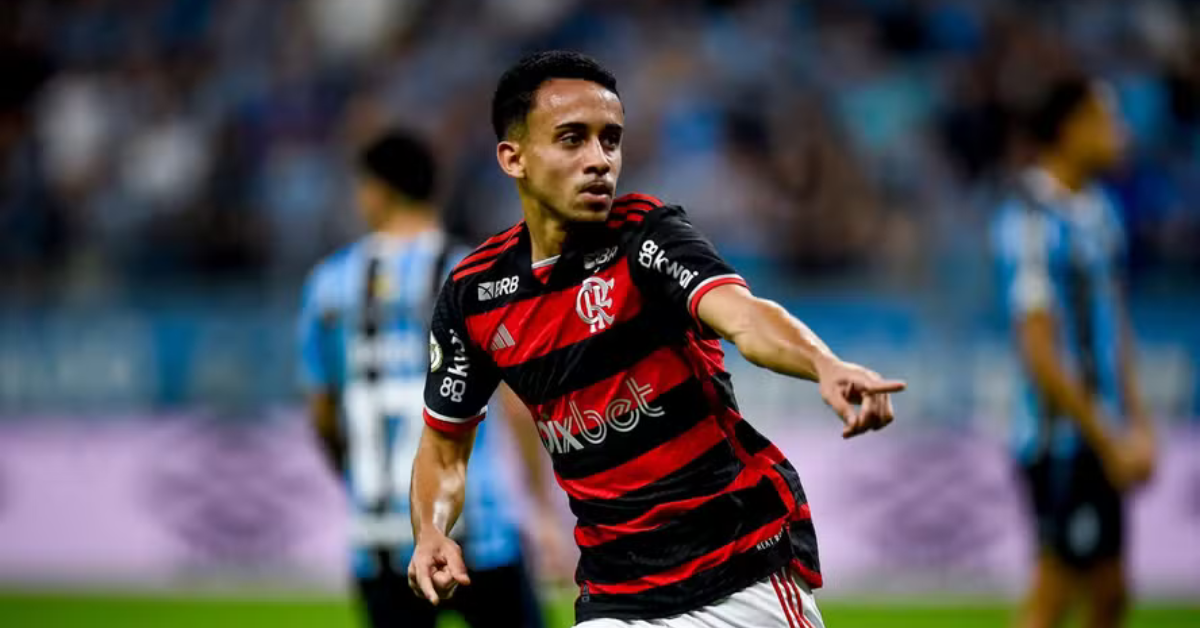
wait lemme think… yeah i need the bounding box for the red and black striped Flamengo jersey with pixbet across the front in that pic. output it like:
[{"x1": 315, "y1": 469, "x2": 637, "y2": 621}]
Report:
[{"x1": 425, "y1": 195, "x2": 821, "y2": 622}]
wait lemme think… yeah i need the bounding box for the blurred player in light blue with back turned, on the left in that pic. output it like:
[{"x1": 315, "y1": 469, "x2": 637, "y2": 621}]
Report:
[{"x1": 300, "y1": 132, "x2": 552, "y2": 628}]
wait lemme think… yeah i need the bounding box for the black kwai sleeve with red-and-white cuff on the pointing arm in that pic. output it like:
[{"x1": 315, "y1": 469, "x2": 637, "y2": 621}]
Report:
[{"x1": 630, "y1": 207, "x2": 746, "y2": 319}]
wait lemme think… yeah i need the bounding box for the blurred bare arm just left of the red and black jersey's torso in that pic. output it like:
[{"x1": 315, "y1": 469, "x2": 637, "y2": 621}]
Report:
[{"x1": 497, "y1": 384, "x2": 571, "y2": 581}]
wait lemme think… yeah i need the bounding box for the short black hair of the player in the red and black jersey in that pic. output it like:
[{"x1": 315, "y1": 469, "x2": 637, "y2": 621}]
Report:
[{"x1": 492, "y1": 50, "x2": 620, "y2": 140}]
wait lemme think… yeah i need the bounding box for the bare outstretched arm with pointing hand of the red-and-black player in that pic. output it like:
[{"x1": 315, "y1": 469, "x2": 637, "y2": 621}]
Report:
[{"x1": 696, "y1": 285, "x2": 905, "y2": 438}]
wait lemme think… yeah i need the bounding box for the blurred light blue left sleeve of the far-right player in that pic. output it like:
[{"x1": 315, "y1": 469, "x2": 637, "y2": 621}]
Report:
[{"x1": 994, "y1": 207, "x2": 1054, "y2": 317}]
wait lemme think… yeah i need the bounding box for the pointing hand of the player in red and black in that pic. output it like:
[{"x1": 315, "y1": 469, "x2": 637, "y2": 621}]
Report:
[{"x1": 817, "y1": 360, "x2": 907, "y2": 438}]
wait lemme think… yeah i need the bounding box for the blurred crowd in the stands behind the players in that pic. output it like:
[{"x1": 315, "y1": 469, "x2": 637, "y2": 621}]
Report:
[{"x1": 0, "y1": 0, "x2": 1200, "y2": 300}]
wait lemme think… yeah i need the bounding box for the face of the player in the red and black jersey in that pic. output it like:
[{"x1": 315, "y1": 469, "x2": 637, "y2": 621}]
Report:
[{"x1": 506, "y1": 79, "x2": 625, "y2": 222}]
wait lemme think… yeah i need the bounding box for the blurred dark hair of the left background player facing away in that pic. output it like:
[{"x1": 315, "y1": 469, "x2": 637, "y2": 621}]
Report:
[{"x1": 359, "y1": 130, "x2": 437, "y2": 203}]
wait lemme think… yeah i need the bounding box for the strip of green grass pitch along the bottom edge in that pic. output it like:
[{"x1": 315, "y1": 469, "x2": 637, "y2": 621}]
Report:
[{"x1": 0, "y1": 592, "x2": 1200, "y2": 628}]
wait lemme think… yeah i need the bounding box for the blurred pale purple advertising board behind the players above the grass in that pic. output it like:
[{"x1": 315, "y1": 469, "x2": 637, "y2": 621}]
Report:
[{"x1": 0, "y1": 413, "x2": 1200, "y2": 598}]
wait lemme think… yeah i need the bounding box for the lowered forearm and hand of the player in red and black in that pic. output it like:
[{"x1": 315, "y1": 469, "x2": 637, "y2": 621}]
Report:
[{"x1": 408, "y1": 426, "x2": 475, "y2": 605}]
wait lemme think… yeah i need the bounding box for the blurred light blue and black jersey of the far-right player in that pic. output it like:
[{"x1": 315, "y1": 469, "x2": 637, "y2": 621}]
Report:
[{"x1": 992, "y1": 169, "x2": 1126, "y2": 461}]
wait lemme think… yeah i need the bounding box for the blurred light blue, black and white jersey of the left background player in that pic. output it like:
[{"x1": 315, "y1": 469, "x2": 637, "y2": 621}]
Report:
[{"x1": 299, "y1": 231, "x2": 520, "y2": 576}]
